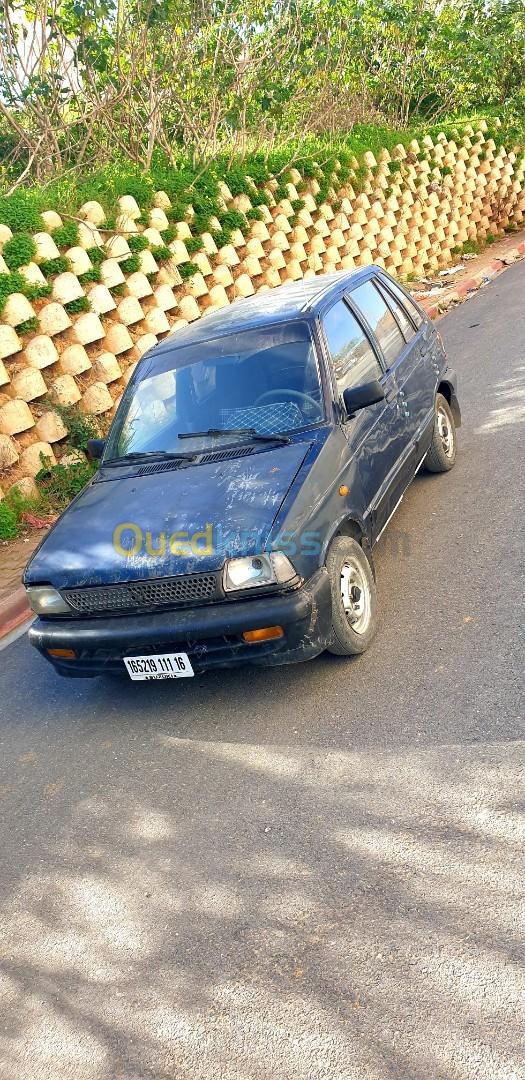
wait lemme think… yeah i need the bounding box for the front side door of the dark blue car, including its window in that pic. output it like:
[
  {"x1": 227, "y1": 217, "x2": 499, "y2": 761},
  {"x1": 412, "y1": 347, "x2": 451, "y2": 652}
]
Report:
[{"x1": 322, "y1": 299, "x2": 399, "y2": 540}]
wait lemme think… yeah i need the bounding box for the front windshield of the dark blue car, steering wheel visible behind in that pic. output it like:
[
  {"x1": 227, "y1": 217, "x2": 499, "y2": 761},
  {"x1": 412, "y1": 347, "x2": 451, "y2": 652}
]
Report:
[{"x1": 104, "y1": 322, "x2": 324, "y2": 461}]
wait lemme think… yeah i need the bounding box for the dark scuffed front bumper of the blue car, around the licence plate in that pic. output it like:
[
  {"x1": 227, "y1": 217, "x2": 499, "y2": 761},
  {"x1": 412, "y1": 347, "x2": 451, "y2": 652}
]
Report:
[{"x1": 29, "y1": 567, "x2": 332, "y2": 678}]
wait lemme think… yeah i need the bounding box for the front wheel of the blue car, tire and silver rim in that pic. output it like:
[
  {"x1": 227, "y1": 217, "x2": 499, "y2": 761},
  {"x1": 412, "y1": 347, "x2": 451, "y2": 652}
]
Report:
[{"x1": 326, "y1": 537, "x2": 377, "y2": 657}]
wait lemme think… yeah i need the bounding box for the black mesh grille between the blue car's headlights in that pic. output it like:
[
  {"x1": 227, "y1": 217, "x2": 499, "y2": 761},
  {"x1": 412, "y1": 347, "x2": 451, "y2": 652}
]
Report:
[{"x1": 62, "y1": 573, "x2": 223, "y2": 615}]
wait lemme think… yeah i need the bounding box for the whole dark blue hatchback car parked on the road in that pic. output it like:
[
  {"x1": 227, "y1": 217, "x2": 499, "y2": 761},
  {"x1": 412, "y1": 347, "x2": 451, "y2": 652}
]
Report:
[{"x1": 25, "y1": 267, "x2": 460, "y2": 680}]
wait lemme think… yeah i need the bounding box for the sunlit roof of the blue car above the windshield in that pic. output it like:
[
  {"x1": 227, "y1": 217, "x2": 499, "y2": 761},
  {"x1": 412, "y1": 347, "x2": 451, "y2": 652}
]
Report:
[{"x1": 150, "y1": 267, "x2": 375, "y2": 359}]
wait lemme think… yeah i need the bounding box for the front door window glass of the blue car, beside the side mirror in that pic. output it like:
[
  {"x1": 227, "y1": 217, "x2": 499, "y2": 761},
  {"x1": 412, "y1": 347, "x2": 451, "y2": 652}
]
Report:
[{"x1": 323, "y1": 300, "x2": 382, "y2": 394}]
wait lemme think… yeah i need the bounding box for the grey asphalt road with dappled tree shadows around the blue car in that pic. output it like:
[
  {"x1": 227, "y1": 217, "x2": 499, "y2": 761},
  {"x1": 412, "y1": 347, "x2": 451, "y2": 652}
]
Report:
[{"x1": 0, "y1": 264, "x2": 525, "y2": 1080}]
